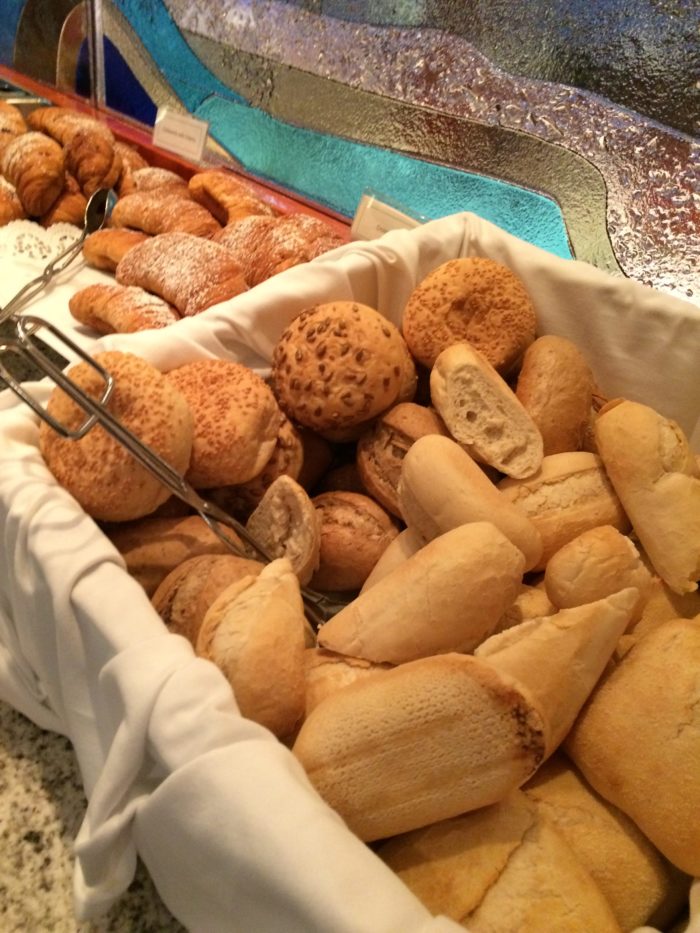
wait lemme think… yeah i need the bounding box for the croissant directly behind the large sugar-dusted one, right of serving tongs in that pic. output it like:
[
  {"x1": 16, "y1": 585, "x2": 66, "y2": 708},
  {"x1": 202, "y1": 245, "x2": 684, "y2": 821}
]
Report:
[{"x1": 112, "y1": 188, "x2": 220, "y2": 237}]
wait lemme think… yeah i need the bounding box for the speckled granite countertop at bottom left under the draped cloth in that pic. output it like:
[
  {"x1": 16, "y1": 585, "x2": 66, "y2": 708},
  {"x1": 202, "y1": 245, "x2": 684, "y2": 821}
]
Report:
[{"x1": 0, "y1": 703, "x2": 184, "y2": 933}]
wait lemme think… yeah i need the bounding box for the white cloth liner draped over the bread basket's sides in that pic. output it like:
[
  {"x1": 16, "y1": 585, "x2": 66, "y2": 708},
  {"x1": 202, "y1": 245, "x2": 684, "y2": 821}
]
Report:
[{"x1": 0, "y1": 214, "x2": 700, "y2": 933}]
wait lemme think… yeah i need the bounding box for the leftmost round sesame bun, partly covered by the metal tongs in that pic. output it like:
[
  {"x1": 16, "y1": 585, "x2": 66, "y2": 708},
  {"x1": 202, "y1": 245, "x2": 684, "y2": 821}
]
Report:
[{"x1": 39, "y1": 350, "x2": 194, "y2": 522}]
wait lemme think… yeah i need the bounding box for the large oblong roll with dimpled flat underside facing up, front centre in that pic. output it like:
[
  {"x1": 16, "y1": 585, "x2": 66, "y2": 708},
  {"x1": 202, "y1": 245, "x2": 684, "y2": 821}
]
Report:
[{"x1": 293, "y1": 654, "x2": 544, "y2": 841}]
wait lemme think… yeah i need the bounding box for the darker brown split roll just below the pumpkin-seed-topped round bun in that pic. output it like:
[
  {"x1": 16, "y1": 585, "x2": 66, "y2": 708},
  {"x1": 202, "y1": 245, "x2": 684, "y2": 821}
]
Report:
[{"x1": 357, "y1": 402, "x2": 447, "y2": 518}]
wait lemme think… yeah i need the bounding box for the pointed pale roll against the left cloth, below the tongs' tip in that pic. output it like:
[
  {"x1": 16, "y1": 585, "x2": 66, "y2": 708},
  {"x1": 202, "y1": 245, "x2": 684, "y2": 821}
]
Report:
[{"x1": 197, "y1": 558, "x2": 306, "y2": 738}]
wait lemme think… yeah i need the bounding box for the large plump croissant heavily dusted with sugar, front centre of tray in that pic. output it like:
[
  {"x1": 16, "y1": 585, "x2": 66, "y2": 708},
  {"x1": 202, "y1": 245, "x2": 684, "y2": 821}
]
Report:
[{"x1": 116, "y1": 230, "x2": 247, "y2": 316}]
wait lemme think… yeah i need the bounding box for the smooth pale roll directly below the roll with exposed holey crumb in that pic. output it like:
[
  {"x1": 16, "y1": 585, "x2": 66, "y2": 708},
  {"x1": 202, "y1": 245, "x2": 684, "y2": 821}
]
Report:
[{"x1": 399, "y1": 434, "x2": 542, "y2": 571}]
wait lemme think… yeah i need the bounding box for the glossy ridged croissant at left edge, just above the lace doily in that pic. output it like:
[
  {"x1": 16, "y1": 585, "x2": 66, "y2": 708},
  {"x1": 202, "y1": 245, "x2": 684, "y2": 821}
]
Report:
[{"x1": 0, "y1": 132, "x2": 66, "y2": 217}]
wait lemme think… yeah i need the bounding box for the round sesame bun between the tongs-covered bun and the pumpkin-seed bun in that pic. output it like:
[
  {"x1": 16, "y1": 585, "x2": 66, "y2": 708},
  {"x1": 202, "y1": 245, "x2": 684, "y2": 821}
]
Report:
[{"x1": 168, "y1": 359, "x2": 282, "y2": 489}]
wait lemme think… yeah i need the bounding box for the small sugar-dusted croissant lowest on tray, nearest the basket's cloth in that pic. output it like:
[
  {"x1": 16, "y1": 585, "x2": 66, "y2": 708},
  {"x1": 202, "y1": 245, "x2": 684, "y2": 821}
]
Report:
[{"x1": 68, "y1": 284, "x2": 180, "y2": 334}]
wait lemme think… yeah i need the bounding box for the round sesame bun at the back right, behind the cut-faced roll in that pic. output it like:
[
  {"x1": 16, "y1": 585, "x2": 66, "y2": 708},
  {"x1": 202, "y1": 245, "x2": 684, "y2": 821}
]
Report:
[{"x1": 402, "y1": 256, "x2": 537, "y2": 374}]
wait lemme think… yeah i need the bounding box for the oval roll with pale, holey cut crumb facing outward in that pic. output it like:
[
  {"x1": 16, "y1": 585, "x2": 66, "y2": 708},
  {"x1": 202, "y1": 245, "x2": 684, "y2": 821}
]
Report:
[{"x1": 430, "y1": 343, "x2": 542, "y2": 478}]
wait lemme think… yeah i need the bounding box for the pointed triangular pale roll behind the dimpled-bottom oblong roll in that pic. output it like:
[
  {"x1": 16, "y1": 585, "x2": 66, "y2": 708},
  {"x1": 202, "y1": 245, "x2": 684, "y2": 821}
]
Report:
[{"x1": 475, "y1": 589, "x2": 637, "y2": 755}]
